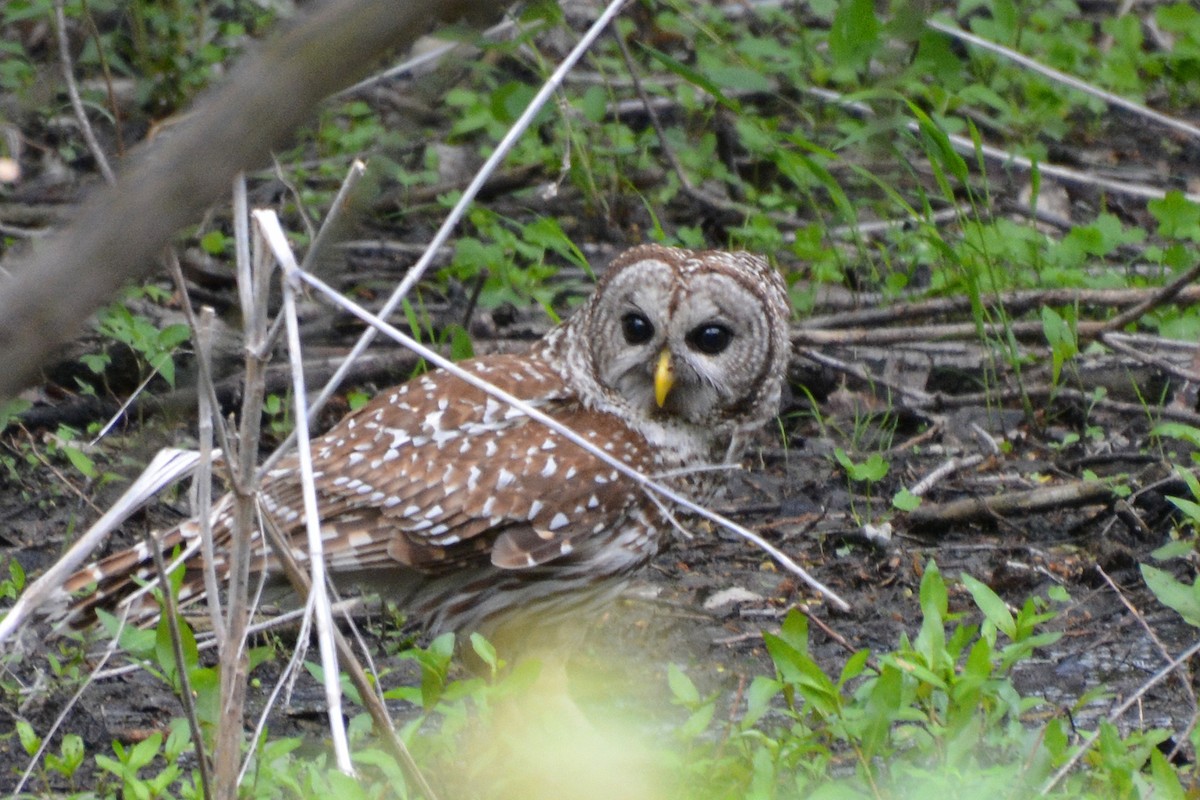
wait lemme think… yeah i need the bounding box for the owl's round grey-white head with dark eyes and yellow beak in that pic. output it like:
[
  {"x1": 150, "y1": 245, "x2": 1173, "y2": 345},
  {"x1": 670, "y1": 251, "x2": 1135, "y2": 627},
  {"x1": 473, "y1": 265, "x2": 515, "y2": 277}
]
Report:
[{"x1": 564, "y1": 245, "x2": 791, "y2": 448}]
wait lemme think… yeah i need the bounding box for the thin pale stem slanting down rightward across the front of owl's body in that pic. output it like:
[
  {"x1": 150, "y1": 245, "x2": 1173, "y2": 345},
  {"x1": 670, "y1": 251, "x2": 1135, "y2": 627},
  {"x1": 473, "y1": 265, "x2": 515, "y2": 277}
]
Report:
[{"x1": 283, "y1": 265, "x2": 850, "y2": 610}]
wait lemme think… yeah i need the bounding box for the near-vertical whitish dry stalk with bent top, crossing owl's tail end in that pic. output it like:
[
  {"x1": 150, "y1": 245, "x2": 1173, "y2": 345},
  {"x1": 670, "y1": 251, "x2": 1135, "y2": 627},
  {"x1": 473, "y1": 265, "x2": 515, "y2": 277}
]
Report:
[{"x1": 252, "y1": 209, "x2": 354, "y2": 775}]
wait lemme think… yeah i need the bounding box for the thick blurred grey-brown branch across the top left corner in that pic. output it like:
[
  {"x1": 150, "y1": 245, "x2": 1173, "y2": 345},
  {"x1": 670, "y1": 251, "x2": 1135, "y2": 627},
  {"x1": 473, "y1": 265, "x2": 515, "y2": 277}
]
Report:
[{"x1": 0, "y1": 0, "x2": 500, "y2": 398}]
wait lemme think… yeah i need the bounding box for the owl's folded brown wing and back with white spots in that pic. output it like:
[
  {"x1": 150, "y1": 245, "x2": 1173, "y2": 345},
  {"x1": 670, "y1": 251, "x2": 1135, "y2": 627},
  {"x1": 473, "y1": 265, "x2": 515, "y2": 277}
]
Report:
[{"x1": 263, "y1": 355, "x2": 653, "y2": 573}]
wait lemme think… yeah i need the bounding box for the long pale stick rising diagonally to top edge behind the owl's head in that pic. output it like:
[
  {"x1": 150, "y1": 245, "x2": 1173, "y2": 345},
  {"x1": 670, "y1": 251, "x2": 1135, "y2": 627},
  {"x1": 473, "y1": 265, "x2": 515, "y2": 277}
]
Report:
[{"x1": 259, "y1": 0, "x2": 628, "y2": 475}]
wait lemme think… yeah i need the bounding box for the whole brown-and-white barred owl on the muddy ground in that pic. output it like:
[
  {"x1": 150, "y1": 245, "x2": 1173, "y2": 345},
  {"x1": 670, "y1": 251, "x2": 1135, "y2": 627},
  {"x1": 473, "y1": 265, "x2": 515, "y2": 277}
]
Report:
[{"x1": 56, "y1": 245, "x2": 788, "y2": 631}]
